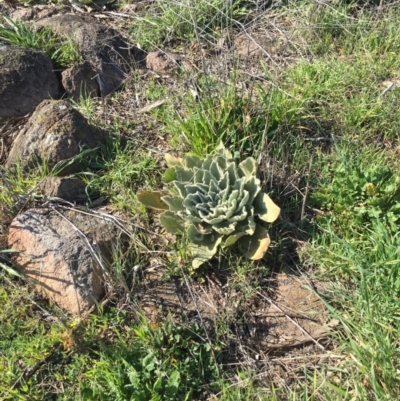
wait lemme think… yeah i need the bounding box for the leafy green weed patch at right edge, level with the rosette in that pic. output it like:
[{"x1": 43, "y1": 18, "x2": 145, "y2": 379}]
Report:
[{"x1": 310, "y1": 148, "x2": 400, "y2": 232}]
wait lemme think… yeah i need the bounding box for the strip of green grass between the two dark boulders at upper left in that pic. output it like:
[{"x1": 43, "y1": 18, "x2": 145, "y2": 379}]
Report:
[{"x1": 0, "y1": 16, "x2": 81, "y2": 68}]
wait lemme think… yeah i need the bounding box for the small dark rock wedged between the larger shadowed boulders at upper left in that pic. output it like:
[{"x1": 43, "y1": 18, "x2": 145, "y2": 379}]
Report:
[{"x1": 61, "y1": 61, "x2": 98, "y2": 100}]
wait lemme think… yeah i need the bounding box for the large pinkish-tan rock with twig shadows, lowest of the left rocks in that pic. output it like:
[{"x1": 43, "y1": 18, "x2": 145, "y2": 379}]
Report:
[{"x1": 8, "y1": 209, "x2": 123, "y2": 315}]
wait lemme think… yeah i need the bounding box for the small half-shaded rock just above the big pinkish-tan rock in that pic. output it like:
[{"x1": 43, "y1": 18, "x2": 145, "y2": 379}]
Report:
[{"x1": 38, "y1": 177, "x2": 86, "y2": 203}]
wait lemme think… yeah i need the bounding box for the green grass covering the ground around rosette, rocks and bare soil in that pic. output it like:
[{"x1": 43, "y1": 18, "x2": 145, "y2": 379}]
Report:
[{"x1": 0, "y1": 1, "x2": 400, "y2": 401}]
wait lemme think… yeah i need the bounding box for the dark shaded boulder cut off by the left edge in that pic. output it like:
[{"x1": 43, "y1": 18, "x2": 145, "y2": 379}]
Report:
[{"x1": 0, "y1": 45, "x2": 59, "y2": 117}]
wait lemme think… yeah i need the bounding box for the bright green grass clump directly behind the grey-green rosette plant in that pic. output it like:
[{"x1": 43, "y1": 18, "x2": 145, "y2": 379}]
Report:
[{"x1": 164, "y1": 72, "x2": 303, "y2": 156}]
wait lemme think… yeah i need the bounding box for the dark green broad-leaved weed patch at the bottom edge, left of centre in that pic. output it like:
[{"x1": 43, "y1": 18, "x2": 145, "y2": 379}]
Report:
[{"x1": 83, "y1": 320, "x2": 218, "y2": 400}]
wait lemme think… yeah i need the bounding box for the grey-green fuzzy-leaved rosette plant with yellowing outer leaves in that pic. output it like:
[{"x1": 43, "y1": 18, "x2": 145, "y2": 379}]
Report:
[{"x1": 138, "y1": 144, "x2": 280, "y2": 268}]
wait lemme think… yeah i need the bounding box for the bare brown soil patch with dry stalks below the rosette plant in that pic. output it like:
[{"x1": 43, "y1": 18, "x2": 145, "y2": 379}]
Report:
[{"x1": 139, "y1": 268, "x2": 337, "y2": 385}]
